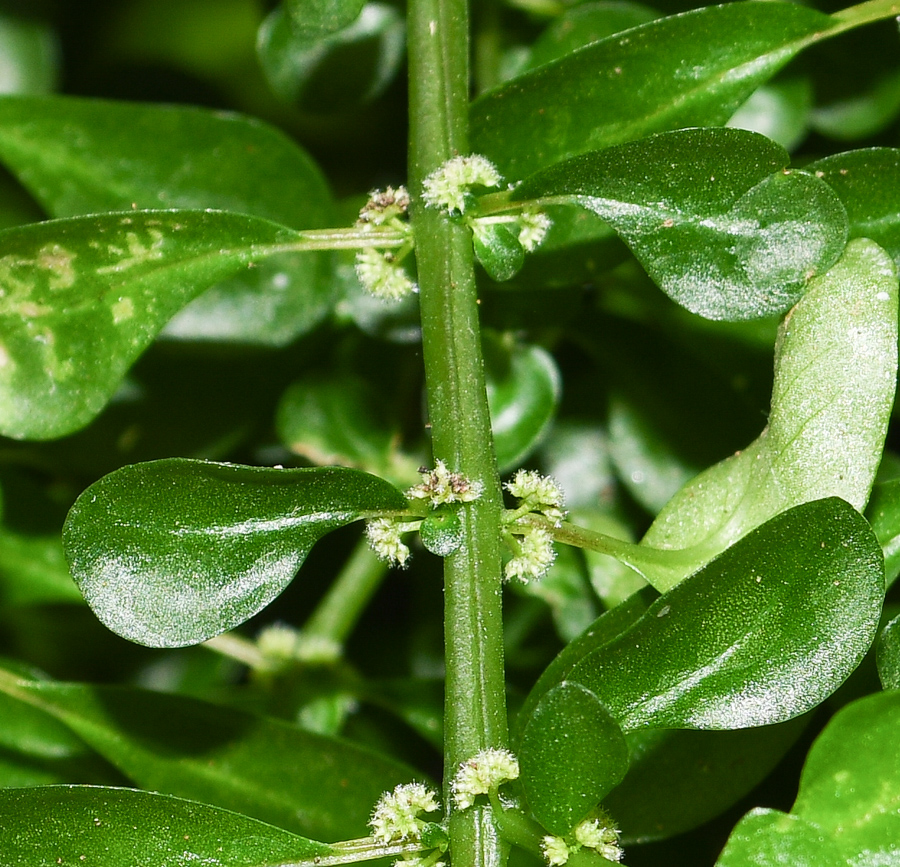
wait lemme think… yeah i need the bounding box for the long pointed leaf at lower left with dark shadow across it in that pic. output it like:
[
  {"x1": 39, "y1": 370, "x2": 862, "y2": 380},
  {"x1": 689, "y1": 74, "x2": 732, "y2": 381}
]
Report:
[{"x1": 0, "y1": 673, "x2": 415, "y2": 840}]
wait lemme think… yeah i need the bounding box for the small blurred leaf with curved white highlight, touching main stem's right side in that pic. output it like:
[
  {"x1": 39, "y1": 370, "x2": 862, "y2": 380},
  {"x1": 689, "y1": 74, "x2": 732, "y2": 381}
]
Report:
[{"x1": 483, "y1": 335, "x2": 561, "y2": 472}]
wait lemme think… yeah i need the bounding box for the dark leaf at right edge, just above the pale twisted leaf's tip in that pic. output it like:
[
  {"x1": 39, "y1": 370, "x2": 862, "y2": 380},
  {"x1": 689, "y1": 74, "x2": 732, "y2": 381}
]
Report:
[{"x1": 806, "y1": 148, "x2": 900, "y2": 265}]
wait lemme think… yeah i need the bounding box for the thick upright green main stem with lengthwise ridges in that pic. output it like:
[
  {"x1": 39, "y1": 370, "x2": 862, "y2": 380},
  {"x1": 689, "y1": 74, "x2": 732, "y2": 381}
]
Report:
[{"x1": 408, "y1": 0, "x2": 507, "y2": 867}]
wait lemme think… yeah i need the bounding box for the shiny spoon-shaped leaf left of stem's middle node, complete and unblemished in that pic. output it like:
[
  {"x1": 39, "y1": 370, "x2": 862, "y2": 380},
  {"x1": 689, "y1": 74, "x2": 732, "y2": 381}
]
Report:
[{"x1": 63, "y1": 458, "x2": 406, "y2": 647}]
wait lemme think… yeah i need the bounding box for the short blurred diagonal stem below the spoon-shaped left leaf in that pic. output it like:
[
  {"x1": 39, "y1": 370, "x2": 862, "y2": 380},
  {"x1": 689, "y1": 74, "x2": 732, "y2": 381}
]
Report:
[{"x1": 303, "y1": 539, "x2": 388, "y2": 644}]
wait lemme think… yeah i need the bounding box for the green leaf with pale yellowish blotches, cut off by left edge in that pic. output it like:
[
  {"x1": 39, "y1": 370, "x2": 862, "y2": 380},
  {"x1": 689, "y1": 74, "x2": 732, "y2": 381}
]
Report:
[{"x1": 0, "y1": 211, "x2": 306, "y2": 439}]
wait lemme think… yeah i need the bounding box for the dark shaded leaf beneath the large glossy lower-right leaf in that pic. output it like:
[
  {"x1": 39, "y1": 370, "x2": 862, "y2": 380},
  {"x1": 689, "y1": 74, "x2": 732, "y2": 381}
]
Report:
[{"x1": 603, "y1": 716, "x2": 809, "y2": 846}]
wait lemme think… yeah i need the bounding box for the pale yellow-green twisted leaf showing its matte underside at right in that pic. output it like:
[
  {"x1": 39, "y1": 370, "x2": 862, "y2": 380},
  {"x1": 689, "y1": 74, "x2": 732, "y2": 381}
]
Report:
[{"x1": 643, "y1": 239, "x2": 897, "y2": 590}]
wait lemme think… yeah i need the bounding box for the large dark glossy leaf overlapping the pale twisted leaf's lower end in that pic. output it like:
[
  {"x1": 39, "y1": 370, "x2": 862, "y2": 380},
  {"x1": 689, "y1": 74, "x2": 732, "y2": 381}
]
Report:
[{"x1": 560, "y1": 498, "x2": 884, "y2": 731}]
